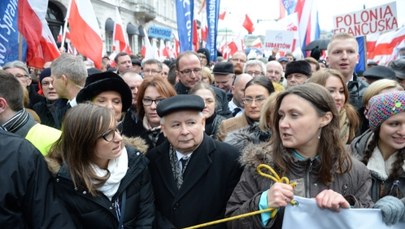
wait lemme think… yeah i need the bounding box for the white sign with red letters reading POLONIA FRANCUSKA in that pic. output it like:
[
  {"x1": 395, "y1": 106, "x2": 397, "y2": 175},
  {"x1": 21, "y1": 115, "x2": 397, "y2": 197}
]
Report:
[{"x1": 333, "y1": 2, "x2": 398, "y2": 36}]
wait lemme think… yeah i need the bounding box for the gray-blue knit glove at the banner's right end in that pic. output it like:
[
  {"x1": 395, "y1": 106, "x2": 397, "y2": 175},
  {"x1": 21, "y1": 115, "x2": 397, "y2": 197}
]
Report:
[{"x1": 374, "y1": 196, "x2": 405, "y2": 225}]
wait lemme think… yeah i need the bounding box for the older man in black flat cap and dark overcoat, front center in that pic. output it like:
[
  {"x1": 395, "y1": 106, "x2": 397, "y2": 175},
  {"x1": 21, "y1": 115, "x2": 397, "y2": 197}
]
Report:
[{"x1": 147, "y1": 95, "x2": 242, "y2": 228}]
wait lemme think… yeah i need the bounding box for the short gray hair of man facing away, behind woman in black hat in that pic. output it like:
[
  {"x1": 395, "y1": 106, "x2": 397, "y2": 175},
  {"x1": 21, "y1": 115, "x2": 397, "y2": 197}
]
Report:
[{"x1": 51, "y1": 53, "x2": 87, "y2": 87}]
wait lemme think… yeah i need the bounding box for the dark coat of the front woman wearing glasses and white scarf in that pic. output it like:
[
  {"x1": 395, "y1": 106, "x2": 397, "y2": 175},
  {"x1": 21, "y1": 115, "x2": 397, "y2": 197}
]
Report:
[{"x1": 49, "y1": 147, "x2": 155, "y2": 229}]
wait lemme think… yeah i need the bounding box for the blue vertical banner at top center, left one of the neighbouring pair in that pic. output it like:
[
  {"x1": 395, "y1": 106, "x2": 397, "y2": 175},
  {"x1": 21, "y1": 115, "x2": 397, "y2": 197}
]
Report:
[{"x1": 176, "y1": 0, "x2": 194, "y2": 52}]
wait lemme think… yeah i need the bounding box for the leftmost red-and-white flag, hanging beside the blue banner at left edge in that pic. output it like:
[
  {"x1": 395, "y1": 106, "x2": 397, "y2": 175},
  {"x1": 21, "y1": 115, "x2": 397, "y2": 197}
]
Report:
[{"x1": 18, "y1": 0, "x2": 60, "y2": 68}]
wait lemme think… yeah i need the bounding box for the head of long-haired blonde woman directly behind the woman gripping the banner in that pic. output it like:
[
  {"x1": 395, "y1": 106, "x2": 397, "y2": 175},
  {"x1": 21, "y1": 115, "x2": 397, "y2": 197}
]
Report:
[{"x1": 307, "y1": 68, "x2": 360, "y2": 144}]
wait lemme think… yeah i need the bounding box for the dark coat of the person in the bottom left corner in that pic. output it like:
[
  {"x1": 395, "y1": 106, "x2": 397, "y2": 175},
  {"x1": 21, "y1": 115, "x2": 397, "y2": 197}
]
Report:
[{"x1": 0, "y1": 130, "x2": 75, "y2": 229}]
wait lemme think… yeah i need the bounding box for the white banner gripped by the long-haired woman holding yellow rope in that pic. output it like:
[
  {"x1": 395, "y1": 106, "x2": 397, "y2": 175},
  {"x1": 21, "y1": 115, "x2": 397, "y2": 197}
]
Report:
[{"x1": 283, "y1": 196, "x2": 405, "y2": 229}]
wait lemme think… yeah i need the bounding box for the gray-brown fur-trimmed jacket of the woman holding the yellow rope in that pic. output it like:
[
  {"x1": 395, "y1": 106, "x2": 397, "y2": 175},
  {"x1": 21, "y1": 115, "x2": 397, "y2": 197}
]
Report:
[{"x1": 226, "y1": 143, "x2": 373, "y2": 228}]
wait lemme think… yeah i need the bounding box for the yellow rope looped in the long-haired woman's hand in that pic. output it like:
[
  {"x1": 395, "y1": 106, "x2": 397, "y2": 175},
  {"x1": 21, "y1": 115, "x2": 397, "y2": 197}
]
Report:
[{"x1": 183, "y1": 164, "x2": 297, "y2": 229}]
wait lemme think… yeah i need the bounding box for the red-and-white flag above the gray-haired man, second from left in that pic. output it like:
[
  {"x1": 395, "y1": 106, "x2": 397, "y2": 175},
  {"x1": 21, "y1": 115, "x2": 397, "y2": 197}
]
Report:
[{"x1": 67, "y1": 0, "x2": 103, "y2": 68}]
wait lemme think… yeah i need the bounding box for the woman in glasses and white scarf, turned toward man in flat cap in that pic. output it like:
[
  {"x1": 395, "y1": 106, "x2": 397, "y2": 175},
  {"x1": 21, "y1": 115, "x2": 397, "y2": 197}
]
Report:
[{"x1": 47, "y1": 103, "x2": 155, "y2": 229}]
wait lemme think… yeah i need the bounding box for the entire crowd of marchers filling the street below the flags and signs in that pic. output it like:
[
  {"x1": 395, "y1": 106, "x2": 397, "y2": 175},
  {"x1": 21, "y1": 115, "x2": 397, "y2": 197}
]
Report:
[{"x1": 0, "y1": 33, "x2": 405, "y2": 228}]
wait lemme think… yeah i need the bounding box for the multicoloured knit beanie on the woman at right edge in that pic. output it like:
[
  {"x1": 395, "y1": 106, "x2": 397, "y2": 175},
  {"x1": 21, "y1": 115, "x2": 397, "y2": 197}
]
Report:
[{"x1": 367, "y1": 91, "x2": 405, "y2": 131}]
